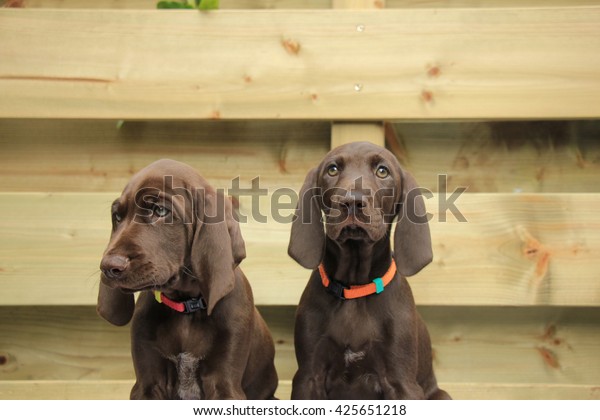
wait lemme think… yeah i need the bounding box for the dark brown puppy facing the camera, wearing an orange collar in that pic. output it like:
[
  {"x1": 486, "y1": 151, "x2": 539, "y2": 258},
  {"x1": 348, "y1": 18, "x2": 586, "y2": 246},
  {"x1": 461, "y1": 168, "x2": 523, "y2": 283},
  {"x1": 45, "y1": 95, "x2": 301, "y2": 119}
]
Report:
[{"x1": 289, "y1": 143, "x2": 450, "y2": 399}]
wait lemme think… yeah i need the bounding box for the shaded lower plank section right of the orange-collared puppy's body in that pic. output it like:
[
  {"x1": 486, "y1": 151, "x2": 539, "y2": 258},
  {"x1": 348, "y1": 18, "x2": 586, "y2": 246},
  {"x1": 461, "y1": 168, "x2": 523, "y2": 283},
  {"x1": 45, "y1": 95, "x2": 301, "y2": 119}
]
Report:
[{"x1": 419, "y1": 307, "x2": 600, "y2": 385}]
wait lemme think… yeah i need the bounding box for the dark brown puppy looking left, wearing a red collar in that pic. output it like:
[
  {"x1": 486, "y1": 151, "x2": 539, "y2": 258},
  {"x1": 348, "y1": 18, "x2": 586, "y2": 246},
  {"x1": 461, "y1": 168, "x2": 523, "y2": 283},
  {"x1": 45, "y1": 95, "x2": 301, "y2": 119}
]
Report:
[{"x1": 98, "y1": 160, "x2": 277, "y2": 399}]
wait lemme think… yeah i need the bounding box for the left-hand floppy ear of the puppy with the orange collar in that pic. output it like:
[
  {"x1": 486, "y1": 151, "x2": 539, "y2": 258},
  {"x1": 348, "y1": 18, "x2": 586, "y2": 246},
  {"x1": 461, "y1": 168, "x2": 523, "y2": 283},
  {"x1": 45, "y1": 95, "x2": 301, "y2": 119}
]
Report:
[{"x1": 288, "y1": 168, "x2": 325, "y2": 269}]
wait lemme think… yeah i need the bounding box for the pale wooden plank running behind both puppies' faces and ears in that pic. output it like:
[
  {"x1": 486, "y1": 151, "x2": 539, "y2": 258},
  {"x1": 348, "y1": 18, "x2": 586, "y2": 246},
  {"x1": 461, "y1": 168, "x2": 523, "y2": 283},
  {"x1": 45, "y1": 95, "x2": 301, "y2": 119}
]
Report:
[{"x1": 0, "y1": 193, "x2": 600, "y2": 306}]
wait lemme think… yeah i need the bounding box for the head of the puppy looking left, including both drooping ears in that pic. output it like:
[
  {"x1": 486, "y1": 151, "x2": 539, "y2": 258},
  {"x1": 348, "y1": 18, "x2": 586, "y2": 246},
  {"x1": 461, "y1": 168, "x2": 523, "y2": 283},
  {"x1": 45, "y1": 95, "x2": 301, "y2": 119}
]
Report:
[{"x1": 97, "y1": 160, "x2": 245, "y2": 325}]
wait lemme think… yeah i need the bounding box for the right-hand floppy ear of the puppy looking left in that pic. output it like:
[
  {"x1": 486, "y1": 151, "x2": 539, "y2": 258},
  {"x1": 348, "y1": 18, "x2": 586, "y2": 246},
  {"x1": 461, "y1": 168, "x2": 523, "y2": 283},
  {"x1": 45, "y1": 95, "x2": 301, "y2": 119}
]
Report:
[{"x1": 190, "y1": 190, "x2": 239, "y2": 315}]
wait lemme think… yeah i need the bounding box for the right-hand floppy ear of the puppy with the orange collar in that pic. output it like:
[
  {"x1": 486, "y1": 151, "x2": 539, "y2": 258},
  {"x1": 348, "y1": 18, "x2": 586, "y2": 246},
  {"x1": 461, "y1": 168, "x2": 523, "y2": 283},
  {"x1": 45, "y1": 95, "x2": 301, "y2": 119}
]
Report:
[{"x1": 394, "y1": 166, "x2": 433, "y2": 276}]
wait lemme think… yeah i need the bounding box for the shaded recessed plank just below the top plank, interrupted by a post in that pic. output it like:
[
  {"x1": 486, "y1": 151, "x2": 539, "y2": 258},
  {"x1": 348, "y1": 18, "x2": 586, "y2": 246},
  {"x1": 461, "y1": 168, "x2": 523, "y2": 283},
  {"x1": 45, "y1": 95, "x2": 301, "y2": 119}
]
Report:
[{"x1": 0, "y1": 119, "x2": 600, "y2": 192}]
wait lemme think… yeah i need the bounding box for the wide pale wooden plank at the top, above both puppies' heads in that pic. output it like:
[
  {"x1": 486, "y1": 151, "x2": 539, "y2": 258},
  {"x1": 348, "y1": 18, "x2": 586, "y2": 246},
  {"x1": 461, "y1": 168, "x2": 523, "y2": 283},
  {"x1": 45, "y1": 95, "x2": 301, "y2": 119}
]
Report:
[{"x1": 0, "y1": 6, "x2": 600, "y2": 120}]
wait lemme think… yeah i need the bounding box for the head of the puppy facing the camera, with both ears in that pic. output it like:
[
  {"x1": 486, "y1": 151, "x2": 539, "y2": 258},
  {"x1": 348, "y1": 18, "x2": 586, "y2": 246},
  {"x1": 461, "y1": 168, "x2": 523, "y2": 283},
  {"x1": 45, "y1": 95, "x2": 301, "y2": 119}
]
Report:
[{"x1": 288, "y1": 142, "x2": 432, "y2": 276}]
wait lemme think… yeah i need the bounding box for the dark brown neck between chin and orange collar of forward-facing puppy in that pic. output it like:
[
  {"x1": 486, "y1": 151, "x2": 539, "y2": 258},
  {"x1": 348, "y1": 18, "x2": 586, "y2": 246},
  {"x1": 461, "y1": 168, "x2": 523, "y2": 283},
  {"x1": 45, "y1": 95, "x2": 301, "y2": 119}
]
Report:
[{"x1": 323, "y1": 235, "x2": 392, "y2": 286}]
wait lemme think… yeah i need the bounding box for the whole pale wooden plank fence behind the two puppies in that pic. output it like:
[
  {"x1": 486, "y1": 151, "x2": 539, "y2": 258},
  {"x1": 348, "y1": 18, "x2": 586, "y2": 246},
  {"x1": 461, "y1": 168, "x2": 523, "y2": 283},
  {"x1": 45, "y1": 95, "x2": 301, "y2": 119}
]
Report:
[{"x1": 0, "y1": 0, "x2": 600, "y2": 399}]
